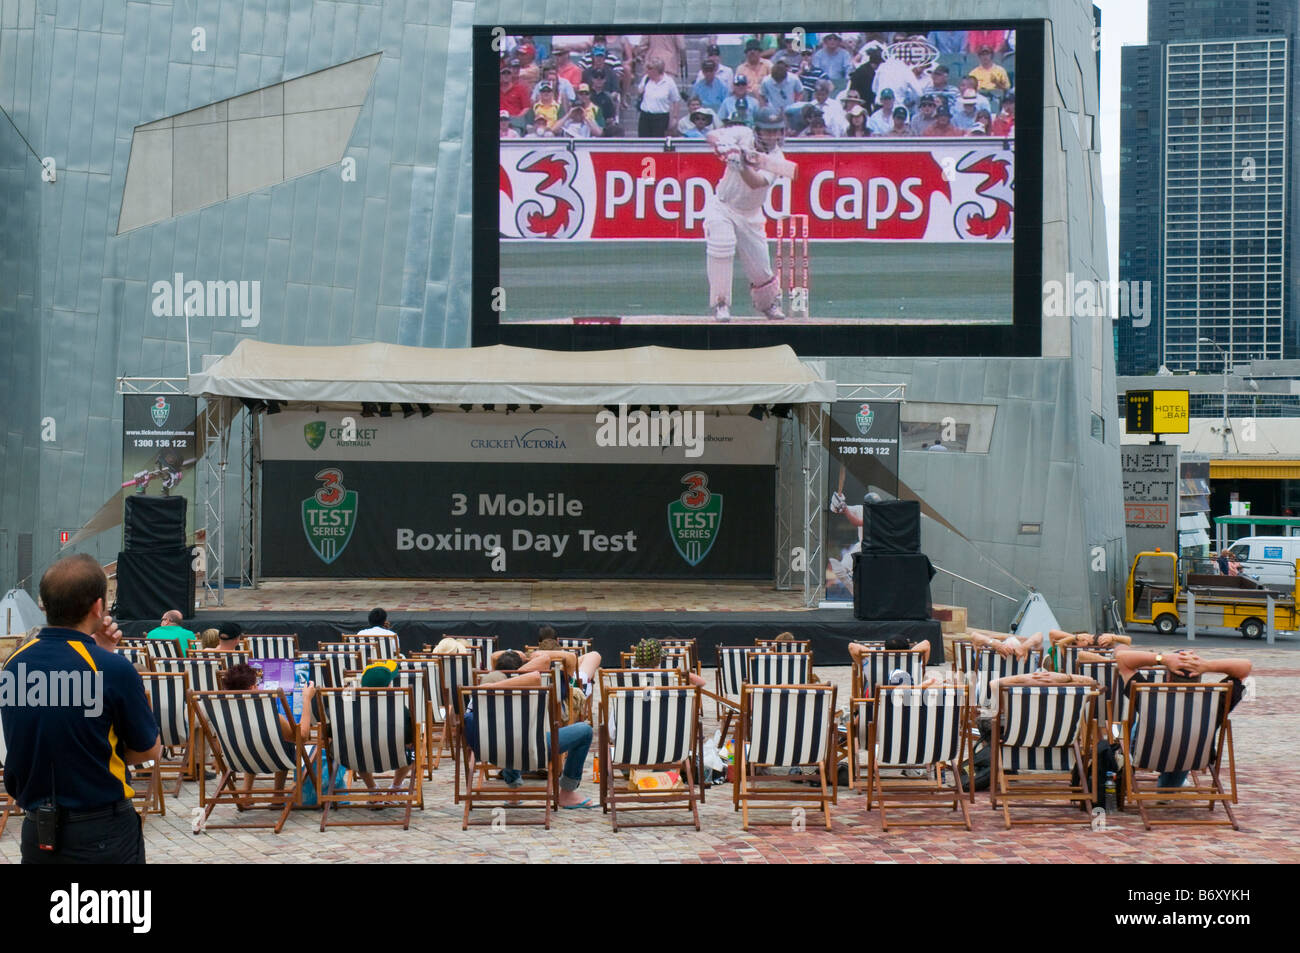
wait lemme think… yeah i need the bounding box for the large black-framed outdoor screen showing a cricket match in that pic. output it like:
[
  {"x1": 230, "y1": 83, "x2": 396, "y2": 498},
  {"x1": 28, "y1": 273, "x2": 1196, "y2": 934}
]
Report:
[{"x1": 475, "y1": 21, "x2": 1043, "y2": 355}]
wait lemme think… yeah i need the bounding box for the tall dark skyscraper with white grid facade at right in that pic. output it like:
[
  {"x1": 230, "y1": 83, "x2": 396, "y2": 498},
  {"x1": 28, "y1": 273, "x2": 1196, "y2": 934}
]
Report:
[{"x1": 1115, "y1": 0, "x2": 1300, "y2": 374}]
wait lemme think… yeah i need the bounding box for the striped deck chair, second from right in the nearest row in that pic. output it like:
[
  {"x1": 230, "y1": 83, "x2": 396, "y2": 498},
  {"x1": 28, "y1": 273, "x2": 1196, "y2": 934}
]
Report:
[{"x1": 989, "y1": 685, "x2": 1100, "y2": 831}]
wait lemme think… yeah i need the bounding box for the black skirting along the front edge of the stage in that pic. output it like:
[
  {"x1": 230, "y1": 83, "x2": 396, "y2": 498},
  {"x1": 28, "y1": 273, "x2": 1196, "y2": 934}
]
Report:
[{"x1": 122, "y1": 608, "x2": 944, "y2": 667}]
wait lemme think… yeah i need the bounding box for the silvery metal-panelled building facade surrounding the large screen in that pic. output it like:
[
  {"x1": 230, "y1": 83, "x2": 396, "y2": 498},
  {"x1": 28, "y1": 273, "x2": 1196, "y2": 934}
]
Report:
[{"x1": 0, "y1": 0, "x2": 1125, "y2": 627}]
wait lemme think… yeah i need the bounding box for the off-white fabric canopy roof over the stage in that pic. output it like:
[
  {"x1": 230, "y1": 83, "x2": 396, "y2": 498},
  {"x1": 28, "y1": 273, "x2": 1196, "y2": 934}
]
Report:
[{"x1": 190, "y1": 341, "x2": 836, "y2": 407}]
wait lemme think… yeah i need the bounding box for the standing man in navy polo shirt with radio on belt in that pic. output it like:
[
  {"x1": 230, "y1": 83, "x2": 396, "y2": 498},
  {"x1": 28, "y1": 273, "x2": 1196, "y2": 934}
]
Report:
[{"x1": 0, "y1": 555, "x2": 163, "y2": 863}]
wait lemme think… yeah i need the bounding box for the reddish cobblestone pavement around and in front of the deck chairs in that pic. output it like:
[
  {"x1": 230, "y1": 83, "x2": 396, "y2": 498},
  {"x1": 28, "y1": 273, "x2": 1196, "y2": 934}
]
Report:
[{"x1": 0, "y1": 640, "x2": 1300, "y2": 863}]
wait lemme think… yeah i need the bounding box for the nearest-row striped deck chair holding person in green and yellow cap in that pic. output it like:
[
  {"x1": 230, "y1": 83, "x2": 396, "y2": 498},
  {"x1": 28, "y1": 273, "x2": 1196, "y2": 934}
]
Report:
[{"x1": 317, "y1": 671, "x2": 424, "y2": 831}]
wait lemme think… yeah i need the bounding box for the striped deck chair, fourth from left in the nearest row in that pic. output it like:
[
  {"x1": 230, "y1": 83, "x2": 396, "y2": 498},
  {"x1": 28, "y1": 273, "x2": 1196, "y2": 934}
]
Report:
[{"x1": 601, "y1": 685, "x2": 699, "y2": 831}]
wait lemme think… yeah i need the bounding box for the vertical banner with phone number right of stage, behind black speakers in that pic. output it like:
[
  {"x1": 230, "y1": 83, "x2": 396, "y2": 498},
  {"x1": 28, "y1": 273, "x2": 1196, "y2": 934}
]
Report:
[{"x1": 823, "y1": 400, "x2": 898, "y2": 602}]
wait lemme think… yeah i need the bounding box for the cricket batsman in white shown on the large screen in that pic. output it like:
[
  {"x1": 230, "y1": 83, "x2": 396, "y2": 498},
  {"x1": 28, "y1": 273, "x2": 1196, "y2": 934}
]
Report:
[{"x1": 705, "y1": 108, "x2": 796, "y2": 321}]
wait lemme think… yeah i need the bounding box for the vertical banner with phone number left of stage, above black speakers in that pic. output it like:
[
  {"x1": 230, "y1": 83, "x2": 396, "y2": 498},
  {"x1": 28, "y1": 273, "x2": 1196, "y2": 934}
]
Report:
[{"x1": 122, "y1": 394, "x2": 199, "y2": 538}]
